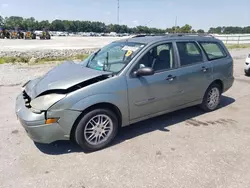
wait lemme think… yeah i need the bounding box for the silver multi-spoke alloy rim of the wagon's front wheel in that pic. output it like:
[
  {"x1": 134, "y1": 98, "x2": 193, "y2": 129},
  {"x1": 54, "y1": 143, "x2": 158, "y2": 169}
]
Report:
[{"x1": 84, "y1": 114, "x2": 113, "y2": 145}]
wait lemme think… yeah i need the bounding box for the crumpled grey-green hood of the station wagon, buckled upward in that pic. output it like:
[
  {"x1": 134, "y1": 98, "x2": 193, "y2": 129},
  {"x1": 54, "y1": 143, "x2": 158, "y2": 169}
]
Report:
[{"x1": 25, "y1": 62, "x2": 109, "y2": 99}]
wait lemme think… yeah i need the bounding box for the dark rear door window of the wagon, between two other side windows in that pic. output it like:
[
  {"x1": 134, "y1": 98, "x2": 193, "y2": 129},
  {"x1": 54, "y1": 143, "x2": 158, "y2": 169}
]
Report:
[{"x1": 176, "y1": 42, "x2": 203, "y2": 66}]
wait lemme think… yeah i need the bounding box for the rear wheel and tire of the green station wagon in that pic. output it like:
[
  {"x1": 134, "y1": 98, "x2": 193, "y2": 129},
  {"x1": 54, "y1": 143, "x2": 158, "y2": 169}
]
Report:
[{"x1": 200, "y1": 83, "x2": 222, "y2": 112}]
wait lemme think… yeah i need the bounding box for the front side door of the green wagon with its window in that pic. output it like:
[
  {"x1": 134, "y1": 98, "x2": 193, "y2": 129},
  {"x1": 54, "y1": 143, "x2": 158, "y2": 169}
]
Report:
[{"x1": 127, "y1": 43, "x2": 183, "y2": 121}]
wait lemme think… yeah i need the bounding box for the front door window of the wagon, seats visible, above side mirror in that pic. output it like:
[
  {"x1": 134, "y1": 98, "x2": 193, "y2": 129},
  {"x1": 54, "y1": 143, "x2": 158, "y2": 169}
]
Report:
[{"x1": 133, "y1": 43, "x2": 174, "y2": 72}]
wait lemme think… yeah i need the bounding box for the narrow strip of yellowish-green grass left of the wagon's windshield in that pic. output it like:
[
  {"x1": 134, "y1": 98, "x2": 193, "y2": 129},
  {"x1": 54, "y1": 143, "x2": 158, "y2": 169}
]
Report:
[{"x1": 0, "y1": 54, "x2": 89, "y2": 64}]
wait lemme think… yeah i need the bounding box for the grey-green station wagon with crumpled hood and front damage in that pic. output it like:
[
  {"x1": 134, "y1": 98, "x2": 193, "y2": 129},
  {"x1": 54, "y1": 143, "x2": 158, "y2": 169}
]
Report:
[{"x1": 16, "y1": 34, "x2": 234, "y2": 151}]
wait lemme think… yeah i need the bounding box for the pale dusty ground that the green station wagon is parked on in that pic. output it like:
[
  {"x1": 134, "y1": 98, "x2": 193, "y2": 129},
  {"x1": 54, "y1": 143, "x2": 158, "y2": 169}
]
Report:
[{"x1": 0, "y1": 49, "x2": 250, "y2": 188}]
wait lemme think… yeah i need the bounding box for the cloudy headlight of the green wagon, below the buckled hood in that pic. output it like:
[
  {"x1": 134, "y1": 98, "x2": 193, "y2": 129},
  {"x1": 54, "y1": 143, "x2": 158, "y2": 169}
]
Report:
[{"x1": 30, "y1": 94, "x2": 66, "y2": 111}]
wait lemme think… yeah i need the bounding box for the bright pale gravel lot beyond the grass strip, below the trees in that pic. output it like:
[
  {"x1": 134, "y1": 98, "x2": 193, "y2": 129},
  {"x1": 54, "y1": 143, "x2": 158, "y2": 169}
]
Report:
[{"x1": 0, "y1": 37, "x2": 121, "y2": 59}]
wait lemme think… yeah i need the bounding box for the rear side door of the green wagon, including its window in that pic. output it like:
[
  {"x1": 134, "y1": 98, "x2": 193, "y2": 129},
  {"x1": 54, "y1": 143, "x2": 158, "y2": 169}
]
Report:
[{"x1": 176, "y1": 41, "x2": 213, "y2": 105}]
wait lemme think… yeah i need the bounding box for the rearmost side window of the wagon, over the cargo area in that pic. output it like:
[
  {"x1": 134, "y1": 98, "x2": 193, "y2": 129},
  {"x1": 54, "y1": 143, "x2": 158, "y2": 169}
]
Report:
[{"x1": 200, "y1": 42, "x2": 227, "y2": 61}]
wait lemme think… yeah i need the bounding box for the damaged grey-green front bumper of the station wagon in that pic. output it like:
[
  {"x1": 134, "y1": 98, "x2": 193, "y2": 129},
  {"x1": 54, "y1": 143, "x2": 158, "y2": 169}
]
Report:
[{"x1": 16, "y1": 94, "x2": 69, "y2": 144}]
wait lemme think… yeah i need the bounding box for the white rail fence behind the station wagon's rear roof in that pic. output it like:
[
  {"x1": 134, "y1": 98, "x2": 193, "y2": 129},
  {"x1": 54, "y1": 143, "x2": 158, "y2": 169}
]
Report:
[{"x1": 213, "y1": 34, "x2": 250, "y2": 44}]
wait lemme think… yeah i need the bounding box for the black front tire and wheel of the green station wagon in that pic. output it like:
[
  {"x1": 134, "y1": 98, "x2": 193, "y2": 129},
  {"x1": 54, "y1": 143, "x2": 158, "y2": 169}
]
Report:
[{"x1": 75, "y1": 109, "x2": 118, "y2": 151}]
